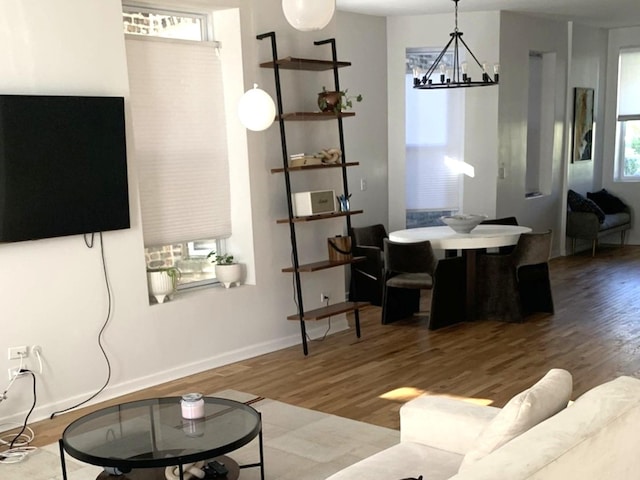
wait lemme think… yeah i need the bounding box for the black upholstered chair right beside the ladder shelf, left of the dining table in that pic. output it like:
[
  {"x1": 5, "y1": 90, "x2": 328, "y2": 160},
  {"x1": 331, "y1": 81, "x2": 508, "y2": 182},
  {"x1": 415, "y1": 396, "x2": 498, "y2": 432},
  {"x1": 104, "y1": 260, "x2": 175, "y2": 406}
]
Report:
[{"x1": 349, "y1": 224, "x2": 387, "y2": 306}]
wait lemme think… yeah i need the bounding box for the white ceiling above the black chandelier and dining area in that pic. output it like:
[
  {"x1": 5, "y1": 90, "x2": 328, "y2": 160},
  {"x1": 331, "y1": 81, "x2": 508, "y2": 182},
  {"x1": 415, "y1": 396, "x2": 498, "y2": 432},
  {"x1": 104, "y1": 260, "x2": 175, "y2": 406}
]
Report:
[{"x1": 336, "y1": 0, "x2": 640, "y2": 28}]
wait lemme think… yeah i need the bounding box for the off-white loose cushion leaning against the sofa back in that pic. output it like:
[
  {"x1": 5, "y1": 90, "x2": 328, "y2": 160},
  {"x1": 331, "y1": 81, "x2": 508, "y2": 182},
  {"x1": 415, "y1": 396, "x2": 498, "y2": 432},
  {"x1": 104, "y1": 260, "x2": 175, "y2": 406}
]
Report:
[{"x1": 460, "y1": 368, "x2": 573, "y2": 471}]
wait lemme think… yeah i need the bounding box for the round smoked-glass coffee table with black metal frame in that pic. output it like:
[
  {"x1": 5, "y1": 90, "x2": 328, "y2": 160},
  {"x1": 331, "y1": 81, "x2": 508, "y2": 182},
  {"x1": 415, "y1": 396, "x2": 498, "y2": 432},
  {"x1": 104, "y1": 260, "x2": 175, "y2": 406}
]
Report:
[{"x1": 59, "y1": 397, "x2": 264, "y2": 480}]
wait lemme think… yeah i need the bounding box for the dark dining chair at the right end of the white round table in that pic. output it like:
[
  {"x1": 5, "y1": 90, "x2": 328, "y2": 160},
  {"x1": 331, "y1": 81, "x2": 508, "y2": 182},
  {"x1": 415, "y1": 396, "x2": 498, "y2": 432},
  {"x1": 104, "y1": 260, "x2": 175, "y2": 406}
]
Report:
[{"x1": 477, "y1": 230, "x2": 554, "y2": 322}]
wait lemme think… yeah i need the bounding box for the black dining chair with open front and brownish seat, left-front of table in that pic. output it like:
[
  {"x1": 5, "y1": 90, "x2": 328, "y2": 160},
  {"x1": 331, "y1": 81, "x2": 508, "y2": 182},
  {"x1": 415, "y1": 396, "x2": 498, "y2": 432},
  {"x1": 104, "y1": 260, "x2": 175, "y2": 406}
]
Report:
[{"x1": 382, "y1": 239, "x2": 437, "y2": 324}]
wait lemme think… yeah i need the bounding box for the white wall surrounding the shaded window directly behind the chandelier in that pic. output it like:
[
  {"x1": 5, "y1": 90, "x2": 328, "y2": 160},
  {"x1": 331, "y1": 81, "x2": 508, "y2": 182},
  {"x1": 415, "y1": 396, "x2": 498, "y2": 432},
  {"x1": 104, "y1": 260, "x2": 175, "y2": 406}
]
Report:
[{"x1": 387, "y1": 12, "x2": 500, "y2": 230}]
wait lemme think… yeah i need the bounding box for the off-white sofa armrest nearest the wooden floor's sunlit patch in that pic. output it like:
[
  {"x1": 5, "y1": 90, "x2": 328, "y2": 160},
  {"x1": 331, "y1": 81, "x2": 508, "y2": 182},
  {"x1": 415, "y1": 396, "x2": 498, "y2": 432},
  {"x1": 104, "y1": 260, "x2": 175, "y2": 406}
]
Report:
[{"x1": 400, "y1": 395, "x2": 500, "y2": 455}]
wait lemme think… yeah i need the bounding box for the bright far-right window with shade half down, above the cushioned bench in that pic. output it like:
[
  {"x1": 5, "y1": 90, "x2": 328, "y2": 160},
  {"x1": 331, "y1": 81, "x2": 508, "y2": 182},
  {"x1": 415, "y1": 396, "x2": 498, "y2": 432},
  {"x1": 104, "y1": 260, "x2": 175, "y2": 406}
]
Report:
[{"x1": 616, "y1": 48, "x2": 640, "y2": 181}]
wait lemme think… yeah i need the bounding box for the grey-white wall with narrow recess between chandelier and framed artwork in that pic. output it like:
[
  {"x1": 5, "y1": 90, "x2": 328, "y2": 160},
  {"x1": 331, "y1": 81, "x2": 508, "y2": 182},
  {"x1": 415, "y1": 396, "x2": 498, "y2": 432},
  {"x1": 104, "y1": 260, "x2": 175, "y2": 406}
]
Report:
[{"x1": 496, "y1": 12, "x2": 568, "y2": 255}]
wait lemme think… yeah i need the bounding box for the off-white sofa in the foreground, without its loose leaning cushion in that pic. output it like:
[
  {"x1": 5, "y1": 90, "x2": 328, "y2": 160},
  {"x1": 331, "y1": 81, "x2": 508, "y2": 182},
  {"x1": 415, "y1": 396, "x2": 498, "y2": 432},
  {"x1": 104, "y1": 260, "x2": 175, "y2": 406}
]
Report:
[{"x1": 330, "y1": 376, "x2": 640, "y2": 480}]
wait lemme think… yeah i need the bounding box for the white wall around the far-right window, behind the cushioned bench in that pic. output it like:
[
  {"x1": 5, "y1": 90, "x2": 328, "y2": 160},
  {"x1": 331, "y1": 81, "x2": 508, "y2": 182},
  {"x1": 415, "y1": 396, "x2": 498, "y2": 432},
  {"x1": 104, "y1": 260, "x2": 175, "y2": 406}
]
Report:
[{"x1": 602, "y1": 27, "x2": 640, "y2": 244}]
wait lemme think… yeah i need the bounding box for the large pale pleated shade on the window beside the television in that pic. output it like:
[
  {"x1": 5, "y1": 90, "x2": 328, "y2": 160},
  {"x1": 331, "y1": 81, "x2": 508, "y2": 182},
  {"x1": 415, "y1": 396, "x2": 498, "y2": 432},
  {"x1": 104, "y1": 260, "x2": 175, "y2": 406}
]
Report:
[{"x1": 126, "y1": 37, "x2": 231, "y2": 246}]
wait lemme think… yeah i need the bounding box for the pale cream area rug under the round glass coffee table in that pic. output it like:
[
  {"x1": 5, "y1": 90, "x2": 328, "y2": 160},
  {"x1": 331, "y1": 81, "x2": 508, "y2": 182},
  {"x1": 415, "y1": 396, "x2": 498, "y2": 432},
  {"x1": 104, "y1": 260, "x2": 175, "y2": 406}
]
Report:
[{"x1": 0, "y1": 390, "x2": 400, "y2": 480}]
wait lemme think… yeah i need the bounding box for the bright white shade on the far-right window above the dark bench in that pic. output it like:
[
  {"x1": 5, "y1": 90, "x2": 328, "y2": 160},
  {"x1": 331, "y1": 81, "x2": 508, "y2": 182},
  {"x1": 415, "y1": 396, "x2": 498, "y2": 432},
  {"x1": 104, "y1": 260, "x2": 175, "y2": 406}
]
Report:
[{"x1": 618, "y1": 48, "x2": 640, "y2": 122}]
